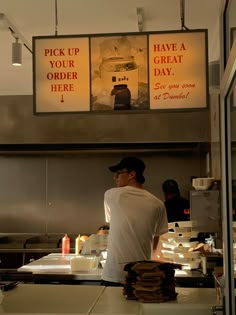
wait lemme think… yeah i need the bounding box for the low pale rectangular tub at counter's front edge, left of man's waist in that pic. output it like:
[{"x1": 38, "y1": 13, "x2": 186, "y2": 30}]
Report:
[{"x1": 70, "y1": 256, "x2": 99, "y2": 272}]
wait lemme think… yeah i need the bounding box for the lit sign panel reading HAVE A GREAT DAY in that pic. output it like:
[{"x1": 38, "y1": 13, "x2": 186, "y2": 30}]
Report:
[{"x1": 149, "y1": 33, "x2": 207, "y2": 109}]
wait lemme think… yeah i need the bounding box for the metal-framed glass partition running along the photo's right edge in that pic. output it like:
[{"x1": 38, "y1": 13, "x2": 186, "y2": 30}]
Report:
[{"x1": 220, "y1": 0, "x2": 236, "y2": 315}]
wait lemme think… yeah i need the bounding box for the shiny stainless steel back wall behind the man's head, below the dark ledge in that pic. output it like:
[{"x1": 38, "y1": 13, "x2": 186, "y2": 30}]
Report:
[{"x1": 0, "y1": 151, "x2": 205, "y2": 233}]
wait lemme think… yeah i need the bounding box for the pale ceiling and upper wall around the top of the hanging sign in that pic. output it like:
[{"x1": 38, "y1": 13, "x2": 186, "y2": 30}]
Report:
[{"x1": 0, "y1": 0, "x2": 222, "y2": 95}]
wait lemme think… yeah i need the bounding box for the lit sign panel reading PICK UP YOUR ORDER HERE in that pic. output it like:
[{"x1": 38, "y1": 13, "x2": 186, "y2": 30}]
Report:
[{"x1": 34, "y1": 37, "x2": 90, "y2": 112}]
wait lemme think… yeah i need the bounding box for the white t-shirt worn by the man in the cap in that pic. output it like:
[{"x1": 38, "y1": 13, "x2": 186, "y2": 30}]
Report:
[{"x1": 102, "y1": 186, "x2": 168, "y2": 283}]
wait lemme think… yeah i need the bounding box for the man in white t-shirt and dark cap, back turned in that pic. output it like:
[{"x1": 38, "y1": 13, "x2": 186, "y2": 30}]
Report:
[{"x1": 102, "y1": 157, "x2": 168, "y2": 286}]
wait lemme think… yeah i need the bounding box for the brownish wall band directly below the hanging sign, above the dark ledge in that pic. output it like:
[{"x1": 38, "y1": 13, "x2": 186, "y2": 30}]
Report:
[{"x1": 0, "y1": 96, "x2": 210, "y2": 145}]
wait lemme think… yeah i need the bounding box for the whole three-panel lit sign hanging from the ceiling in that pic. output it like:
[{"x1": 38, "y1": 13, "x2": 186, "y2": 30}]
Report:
[{"x1": 33, "y1": 30, "x2": 208, "y2": 113}]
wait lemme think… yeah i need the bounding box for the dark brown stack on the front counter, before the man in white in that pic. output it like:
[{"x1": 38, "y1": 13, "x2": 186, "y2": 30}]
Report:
[{"x1": 123, "y1": 260, "x2": 181, "y2": 303}]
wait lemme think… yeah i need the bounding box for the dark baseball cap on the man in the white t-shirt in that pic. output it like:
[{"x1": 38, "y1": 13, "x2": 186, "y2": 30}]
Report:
[{"x1": 109, "y1": 156, "x2": 146, "y2": 175}]
